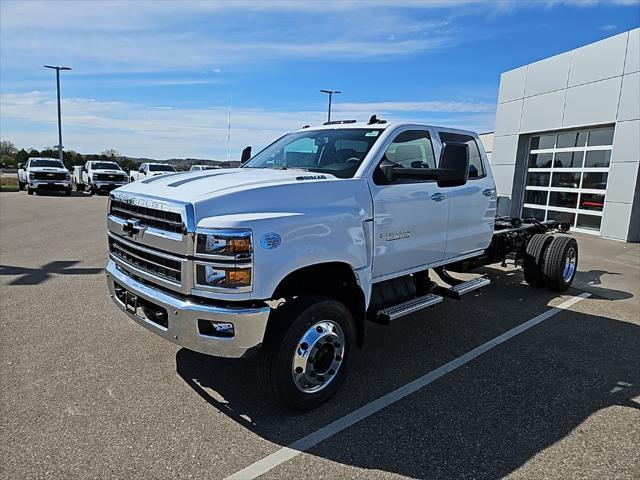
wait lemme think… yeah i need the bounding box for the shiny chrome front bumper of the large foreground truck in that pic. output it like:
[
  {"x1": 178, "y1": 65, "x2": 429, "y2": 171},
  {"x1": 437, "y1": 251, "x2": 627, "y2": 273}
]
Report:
[{"x1": 107, "y1": 260, "x2": 271, "y2": 358}]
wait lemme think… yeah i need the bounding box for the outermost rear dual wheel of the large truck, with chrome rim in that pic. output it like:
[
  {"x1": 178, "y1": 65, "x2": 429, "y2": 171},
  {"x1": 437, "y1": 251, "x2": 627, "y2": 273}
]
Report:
[{"x1": 544, "y1": 237, "x2": 578, "y2": 292}]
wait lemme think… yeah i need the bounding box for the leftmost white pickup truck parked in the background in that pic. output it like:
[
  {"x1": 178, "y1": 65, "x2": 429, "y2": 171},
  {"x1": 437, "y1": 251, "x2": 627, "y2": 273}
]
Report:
[{"x1": 18, "y1": 157, "x2": 71, "y2": 195}]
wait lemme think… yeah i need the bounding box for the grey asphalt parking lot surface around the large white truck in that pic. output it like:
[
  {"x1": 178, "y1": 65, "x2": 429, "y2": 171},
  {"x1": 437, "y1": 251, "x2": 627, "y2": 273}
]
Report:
[{"x1": 0, "y1": 192, "x2": 640, "y2": 479}]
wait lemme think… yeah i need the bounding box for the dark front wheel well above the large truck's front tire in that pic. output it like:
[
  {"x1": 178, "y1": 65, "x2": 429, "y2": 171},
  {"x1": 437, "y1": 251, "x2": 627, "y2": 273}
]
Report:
[{"x1": 273, "y1": 262, "x2": 365, "y2": 347}]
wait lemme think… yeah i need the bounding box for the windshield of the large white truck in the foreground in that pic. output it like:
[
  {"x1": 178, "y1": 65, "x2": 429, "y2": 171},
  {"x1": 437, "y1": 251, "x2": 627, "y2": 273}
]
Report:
[{"x1": 244, "y1": 128, "x2": 382, "y2": 178}]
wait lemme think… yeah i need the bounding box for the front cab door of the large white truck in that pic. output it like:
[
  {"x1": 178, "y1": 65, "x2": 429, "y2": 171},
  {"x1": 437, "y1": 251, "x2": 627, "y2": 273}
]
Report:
[{"x1": 369, "y1": 129, "x2": 449, "y2": 280}]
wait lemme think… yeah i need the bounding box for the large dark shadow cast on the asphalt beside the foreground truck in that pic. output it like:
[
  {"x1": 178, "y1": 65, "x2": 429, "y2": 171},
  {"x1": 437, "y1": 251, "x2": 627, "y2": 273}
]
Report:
[{"x1": 176, "y1": 272, "x2": 640, "y2": 478}]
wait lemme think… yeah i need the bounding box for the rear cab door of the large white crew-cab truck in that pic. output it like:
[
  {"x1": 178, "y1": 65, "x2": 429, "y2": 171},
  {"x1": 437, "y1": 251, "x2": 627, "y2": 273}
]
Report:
[{"x1": 439, "y1": 131, "x2": 497, "y2": 259}]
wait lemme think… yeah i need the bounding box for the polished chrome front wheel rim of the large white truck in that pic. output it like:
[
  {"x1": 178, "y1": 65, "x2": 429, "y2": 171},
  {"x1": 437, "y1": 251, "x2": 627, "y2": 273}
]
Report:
[{"x1": 291, "y1": 320, "x2": 345, "y2": 393}]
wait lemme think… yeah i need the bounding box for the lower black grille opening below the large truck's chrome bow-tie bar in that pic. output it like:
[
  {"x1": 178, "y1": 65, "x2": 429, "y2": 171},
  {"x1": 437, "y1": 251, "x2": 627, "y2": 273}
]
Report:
[{"x1": 109, "y1": 237, "x2": 182, "y2": 284}]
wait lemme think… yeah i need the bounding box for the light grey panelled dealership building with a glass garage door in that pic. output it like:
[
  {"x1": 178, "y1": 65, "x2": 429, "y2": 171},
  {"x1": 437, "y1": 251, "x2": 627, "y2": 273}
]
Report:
[{"x1": 482, "y1": 29, "x2": 640, "y2": 242}]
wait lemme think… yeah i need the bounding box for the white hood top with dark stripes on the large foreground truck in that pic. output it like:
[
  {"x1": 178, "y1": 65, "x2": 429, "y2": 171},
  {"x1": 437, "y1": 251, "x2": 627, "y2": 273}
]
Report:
[{"x1": 118, "y1": 168, "x2": 337, "y2": 203}]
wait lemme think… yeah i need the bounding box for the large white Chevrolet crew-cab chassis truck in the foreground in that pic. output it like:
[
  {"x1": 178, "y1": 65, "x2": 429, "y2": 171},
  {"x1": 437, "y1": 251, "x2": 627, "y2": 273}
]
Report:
[{"x1": 107, "y1": 117, "x2": 578, "y2": 410}]
